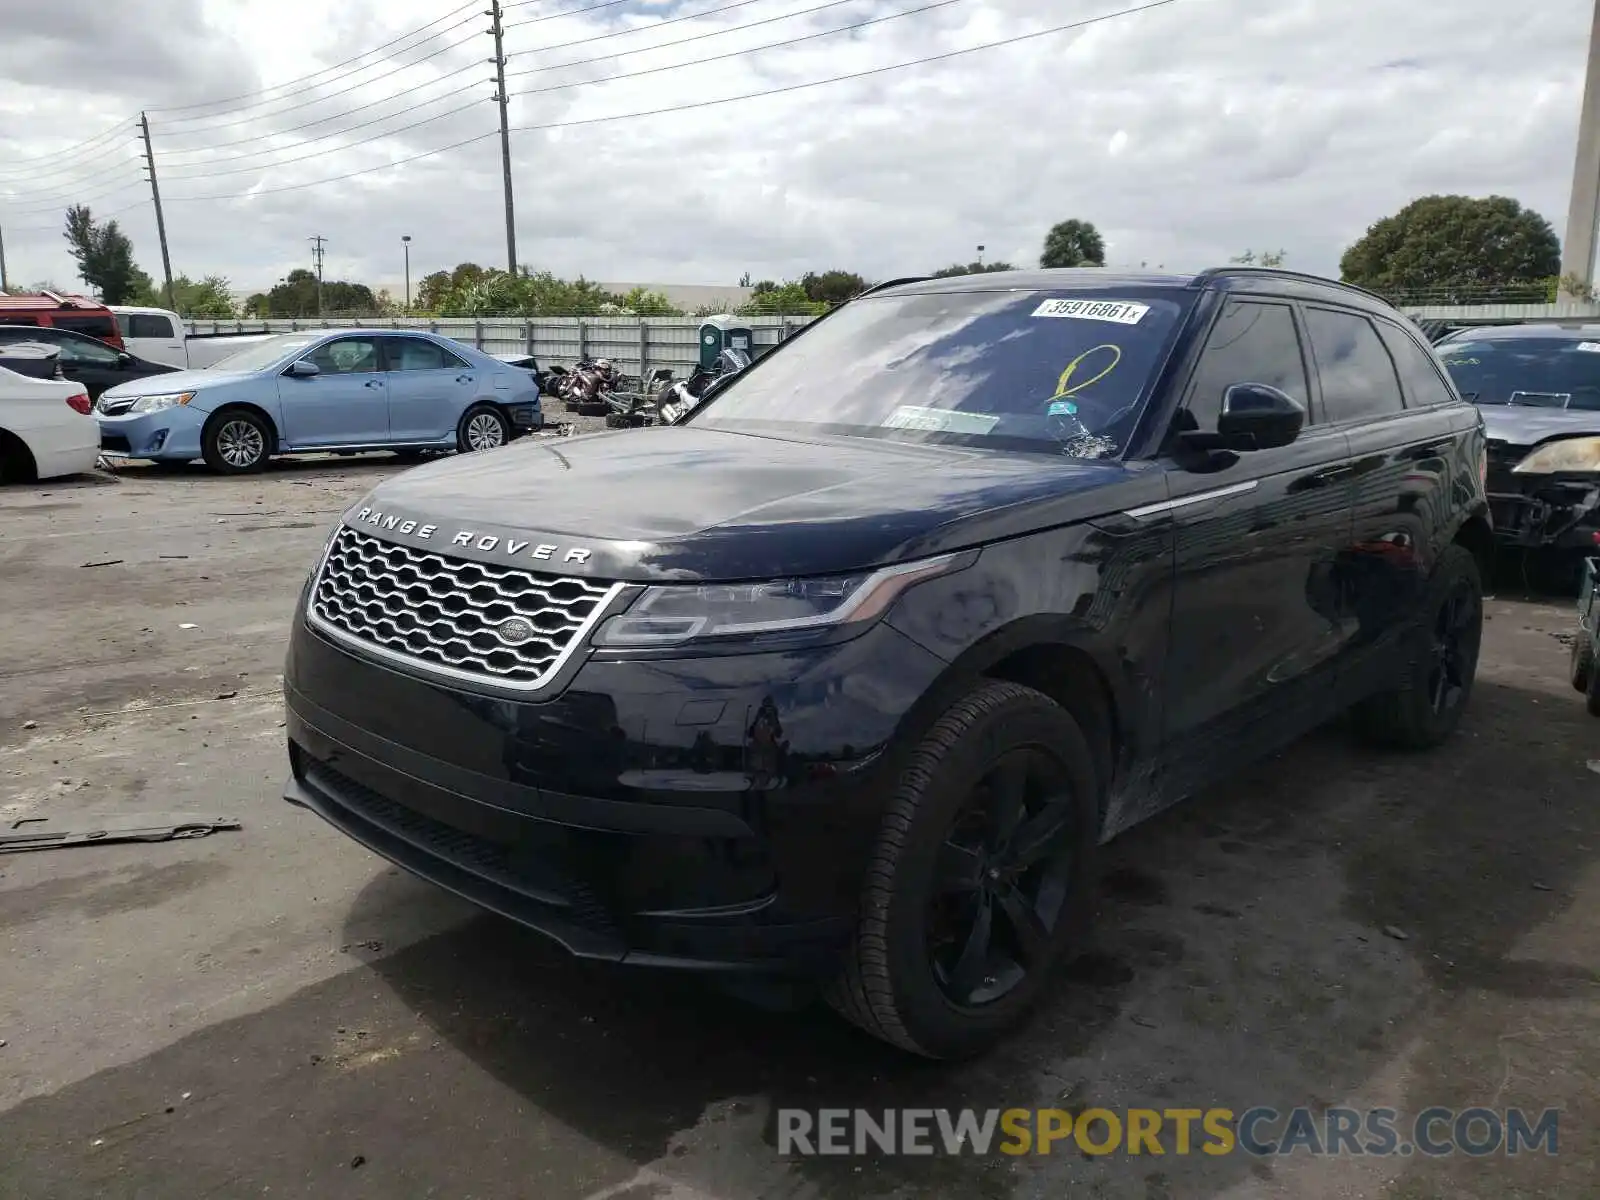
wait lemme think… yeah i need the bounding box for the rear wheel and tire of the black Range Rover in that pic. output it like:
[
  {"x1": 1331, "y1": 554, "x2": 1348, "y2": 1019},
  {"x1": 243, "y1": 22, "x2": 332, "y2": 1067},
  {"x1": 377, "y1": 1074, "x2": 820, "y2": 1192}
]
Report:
[{"x1": 1352, "y1": 544, "x2": 1483, "y2": 750}]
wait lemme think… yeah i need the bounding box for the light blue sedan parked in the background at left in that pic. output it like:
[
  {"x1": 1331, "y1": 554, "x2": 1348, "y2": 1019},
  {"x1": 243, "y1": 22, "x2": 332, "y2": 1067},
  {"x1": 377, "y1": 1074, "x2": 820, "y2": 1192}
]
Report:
[{"x1": 96, "y1": 330, "x2": 544, "y2": 474}]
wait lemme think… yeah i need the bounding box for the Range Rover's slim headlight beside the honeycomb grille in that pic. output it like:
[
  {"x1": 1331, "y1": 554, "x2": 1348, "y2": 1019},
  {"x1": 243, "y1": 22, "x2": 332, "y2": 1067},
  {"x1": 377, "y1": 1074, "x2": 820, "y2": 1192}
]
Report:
[{"x1": 595, "y1": 554, "x2": 962, "y2": 646}]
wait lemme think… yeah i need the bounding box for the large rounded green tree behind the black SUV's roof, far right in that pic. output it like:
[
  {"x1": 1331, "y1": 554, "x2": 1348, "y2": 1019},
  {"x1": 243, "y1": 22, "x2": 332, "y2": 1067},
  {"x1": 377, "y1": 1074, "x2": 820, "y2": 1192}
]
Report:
[{"x1": 1339, "y1": 195, "x2": 1562, "y2": 298}]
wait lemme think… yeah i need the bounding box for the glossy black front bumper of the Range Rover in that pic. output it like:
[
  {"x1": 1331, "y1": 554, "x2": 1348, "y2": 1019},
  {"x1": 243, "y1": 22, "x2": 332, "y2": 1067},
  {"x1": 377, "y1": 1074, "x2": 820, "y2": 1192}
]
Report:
[{"x1": 285, "y1": 611, "x2": 944, "y2": 976}]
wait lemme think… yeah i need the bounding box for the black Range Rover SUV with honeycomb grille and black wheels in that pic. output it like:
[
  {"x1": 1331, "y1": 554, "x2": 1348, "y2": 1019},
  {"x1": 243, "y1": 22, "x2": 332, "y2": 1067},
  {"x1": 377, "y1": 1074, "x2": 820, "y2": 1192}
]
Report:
[{"x1": 285, "y1": 267, "x2": 1491, "y2": 1058}]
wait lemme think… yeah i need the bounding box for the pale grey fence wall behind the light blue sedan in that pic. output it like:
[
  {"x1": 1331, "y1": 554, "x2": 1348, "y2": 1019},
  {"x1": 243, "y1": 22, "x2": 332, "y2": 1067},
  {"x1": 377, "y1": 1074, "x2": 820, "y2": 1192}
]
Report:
[{"x1": 186, "y1": 317, "x2": 813, "y2": 376}]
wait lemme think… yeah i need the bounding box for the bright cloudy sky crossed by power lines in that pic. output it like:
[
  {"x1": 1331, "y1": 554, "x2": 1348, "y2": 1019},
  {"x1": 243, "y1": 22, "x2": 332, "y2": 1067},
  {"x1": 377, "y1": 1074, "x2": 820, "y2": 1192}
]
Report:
[{"x1": 0, "y1": 0, "x2": 1594, "y2": 293}]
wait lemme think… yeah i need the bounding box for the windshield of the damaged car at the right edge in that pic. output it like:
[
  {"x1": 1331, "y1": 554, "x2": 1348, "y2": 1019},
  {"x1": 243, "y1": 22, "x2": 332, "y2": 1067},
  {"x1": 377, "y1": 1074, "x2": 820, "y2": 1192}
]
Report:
[{"x1": 1438, "y1": 338, "x2": 1600, "y2": 410}]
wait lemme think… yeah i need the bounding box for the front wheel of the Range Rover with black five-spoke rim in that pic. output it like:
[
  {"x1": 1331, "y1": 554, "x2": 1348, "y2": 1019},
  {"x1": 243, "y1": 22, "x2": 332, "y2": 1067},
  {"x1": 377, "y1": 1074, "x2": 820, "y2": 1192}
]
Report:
[{"x1": 829, "y1": 682, "x2": 1099, "y2": 1059}]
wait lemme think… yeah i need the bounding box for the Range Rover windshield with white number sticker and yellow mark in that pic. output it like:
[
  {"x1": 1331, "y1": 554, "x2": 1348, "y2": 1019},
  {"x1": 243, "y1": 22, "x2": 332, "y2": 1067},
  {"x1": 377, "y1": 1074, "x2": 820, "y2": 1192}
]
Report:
[{"x1": 693, "y1": 288, "x2": 1192, "y2": 458}]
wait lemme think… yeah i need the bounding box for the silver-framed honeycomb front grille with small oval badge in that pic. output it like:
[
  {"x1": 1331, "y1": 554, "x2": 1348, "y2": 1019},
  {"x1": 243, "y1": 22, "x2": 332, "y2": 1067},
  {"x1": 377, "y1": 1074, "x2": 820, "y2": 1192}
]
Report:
[{"x1": 310, "y1": 526, "x2": 616, "y2": 691}]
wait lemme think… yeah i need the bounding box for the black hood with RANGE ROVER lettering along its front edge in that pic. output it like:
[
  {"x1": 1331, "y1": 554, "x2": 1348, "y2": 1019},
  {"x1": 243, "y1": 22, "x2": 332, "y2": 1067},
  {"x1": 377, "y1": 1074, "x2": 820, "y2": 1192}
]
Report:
[{"x1": 346, "y1": 426, "x2": 1131, "y2": 581}]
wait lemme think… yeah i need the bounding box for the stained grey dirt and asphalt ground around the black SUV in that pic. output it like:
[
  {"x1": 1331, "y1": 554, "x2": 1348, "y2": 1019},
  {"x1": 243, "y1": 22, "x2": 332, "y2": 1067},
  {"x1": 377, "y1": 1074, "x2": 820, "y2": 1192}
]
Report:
[{"x1": 0, "y1": 456, "x2": 1600, "y2": 1200}]
